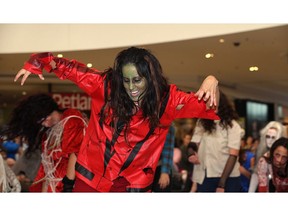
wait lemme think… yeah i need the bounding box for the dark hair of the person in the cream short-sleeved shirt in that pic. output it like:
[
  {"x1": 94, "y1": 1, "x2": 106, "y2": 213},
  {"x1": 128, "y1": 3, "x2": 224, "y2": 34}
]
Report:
[{"x1": 200, "y1": 91, "x2": 239, "y2": 133}]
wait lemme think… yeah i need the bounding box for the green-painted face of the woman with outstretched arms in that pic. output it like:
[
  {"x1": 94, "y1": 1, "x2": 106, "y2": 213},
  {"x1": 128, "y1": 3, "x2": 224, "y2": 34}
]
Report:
[{"x1": 122, "y1": 64, "x2": 147, "y2": 103}]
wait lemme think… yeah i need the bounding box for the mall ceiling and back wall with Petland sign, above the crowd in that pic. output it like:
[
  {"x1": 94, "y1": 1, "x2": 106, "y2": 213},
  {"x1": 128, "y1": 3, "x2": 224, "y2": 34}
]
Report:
[{"x1": 0, "y1": 24, "x2": 288, "y2": 133}]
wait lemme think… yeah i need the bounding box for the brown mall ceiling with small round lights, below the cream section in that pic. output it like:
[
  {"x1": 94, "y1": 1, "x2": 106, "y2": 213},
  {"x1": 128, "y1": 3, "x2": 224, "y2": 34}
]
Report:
[{"x1": 0, "y1": 25, "x2": 288, "y2": 107}]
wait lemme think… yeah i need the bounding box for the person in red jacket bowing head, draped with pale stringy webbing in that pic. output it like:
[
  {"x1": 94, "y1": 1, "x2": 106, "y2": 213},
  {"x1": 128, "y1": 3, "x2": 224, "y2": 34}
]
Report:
[{"x1": 4, "y1": 94, "x2": 87, "y2": 192}]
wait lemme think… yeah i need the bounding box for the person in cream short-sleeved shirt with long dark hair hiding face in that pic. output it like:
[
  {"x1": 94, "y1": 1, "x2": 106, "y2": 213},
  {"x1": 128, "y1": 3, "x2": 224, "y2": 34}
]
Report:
[{"x1": 189, "y1": 92, "x2": 242, "y2": 192}]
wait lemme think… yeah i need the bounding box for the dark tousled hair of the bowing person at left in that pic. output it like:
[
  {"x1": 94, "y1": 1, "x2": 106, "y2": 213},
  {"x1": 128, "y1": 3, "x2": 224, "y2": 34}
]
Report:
[{"x1": 2, "y1": 94, "x2": 60, "y2": 152}]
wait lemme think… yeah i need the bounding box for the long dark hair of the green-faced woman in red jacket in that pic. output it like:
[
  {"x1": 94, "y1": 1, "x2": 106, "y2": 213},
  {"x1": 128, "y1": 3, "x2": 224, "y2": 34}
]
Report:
[{"x1": 102, "y1": 47, "x2": 169, "y2": 132}]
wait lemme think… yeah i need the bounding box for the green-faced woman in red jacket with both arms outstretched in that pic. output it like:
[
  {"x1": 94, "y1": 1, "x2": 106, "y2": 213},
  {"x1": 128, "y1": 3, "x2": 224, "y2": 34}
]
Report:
[{"x1": 14, "y1": 47, "x2": 219, "y2": 192}]
